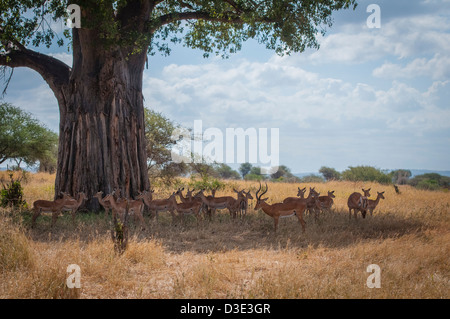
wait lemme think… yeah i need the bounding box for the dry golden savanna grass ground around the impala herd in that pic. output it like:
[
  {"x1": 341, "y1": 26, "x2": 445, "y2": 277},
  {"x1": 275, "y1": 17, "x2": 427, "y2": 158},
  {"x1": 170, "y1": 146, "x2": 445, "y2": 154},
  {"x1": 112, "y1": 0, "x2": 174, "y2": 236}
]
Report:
[{"x1": 0, "y1": 174, "x2": 450, "y2": 299}]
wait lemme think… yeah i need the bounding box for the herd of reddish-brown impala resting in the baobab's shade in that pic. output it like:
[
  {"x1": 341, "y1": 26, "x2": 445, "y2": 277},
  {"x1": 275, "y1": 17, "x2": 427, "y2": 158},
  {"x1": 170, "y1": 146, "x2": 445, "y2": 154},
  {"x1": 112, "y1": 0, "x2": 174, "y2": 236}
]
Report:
[{"x1": 32, "y1": 183, "x2": 384, "y2": 232}]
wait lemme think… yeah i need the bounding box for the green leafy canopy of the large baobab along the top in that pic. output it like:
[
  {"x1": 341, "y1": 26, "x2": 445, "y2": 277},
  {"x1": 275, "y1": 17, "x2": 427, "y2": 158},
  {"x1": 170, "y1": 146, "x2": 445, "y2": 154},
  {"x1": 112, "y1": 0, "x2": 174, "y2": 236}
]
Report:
[{"x1": 0, "y1": 0, "x2": 356, "y2": 57}]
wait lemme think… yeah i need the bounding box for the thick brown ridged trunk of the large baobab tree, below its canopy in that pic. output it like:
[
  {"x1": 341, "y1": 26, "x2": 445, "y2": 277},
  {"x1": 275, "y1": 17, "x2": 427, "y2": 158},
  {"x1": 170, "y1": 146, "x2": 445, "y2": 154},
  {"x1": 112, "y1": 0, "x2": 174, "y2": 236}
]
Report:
[{"x1": 55, "y1": 43, "x2": 149, "y2": 209}]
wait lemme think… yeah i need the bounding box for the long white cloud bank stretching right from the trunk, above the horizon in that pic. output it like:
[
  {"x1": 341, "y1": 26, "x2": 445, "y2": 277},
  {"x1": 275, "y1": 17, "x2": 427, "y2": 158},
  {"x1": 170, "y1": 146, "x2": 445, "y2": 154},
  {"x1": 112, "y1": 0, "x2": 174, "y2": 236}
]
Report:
[{"x1": 144, "y1": 53, "x2": 450, "y2": 138}]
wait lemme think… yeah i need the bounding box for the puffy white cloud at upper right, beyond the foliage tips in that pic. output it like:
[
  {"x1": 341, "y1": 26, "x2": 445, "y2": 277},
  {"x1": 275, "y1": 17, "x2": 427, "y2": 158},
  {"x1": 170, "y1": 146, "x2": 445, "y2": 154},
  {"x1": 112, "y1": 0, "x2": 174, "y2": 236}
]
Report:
[{"x1": 299, "y1": 14, "x2": 450, "y2": 64}]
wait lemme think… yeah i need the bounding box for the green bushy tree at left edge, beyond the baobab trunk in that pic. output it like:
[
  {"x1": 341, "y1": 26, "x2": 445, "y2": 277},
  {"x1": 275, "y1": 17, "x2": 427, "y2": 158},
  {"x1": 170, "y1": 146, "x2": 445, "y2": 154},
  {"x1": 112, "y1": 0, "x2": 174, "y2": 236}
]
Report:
[{"x1": 0, "y1": 103, "x2": 57, "y2": 168}]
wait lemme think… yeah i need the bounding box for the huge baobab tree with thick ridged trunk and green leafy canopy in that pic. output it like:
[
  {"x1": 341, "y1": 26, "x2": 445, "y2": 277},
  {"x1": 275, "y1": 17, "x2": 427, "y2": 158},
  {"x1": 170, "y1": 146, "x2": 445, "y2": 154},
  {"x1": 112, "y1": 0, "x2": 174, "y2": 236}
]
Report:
[{"x1": 0, "y1": 0, "x2": 356, "y2": 210}]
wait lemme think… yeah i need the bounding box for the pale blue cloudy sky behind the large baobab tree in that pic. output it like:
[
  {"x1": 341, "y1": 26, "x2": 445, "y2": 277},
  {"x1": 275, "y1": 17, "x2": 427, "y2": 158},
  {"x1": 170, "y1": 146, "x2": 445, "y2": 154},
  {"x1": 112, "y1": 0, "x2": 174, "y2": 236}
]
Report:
[{"x1": 0, "y1": 0, "x2": 450, "y2": 173}]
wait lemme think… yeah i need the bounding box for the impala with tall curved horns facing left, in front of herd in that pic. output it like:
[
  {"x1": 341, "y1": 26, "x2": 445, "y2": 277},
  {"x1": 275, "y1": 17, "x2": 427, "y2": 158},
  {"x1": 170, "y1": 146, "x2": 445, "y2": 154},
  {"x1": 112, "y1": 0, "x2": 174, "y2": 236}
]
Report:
[{"x1": 255, "y1": 183, "x2": 306, "y2": 232}]
